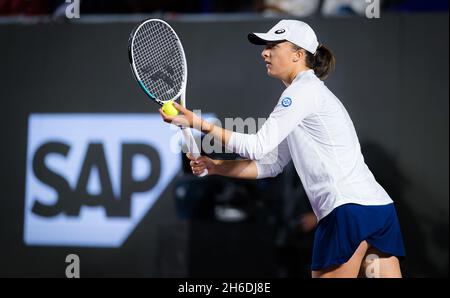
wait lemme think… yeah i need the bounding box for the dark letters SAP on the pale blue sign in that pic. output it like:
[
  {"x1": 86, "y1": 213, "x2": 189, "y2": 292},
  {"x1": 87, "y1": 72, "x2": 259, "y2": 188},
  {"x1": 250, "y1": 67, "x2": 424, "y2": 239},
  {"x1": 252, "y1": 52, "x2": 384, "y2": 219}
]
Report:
[{"x1": 31, "y1": 141, "x2": 161, "y2": 217}]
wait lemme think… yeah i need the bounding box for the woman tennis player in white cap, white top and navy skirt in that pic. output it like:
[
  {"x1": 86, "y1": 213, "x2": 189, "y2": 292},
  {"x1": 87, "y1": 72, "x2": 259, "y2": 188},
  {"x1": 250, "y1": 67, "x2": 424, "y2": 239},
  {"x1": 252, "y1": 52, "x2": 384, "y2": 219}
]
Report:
[{"x1": 160, "y1": 20, "x2": 405, "y2": 277}]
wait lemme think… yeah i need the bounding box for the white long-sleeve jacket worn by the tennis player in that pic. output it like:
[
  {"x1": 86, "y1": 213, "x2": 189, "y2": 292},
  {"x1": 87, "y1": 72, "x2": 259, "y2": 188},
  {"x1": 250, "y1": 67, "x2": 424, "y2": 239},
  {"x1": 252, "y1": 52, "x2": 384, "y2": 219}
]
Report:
[{"x1": 227, "y1": 70, "x2": 392, "y2": 220}]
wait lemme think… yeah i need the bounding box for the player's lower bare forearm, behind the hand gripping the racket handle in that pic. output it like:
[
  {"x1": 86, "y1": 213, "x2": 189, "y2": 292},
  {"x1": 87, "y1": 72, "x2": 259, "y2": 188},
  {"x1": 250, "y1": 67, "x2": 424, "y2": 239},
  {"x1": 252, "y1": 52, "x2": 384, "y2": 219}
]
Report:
[{"x1": 212, "y1": 160, "x2": 258, "y2": 179}]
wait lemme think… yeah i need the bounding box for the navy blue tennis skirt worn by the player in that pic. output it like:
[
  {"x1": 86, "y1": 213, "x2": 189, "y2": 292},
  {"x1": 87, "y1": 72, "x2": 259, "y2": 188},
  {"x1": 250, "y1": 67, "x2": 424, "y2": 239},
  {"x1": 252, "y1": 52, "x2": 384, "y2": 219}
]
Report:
[{"x1": 311, "y1": 203, "x2": 405, "y2": 270}]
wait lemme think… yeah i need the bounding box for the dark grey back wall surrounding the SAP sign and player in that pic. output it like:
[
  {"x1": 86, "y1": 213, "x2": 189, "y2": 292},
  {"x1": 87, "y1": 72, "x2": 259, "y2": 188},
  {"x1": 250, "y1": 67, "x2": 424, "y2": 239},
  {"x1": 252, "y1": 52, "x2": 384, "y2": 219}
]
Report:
[{"x1": 0, "y1": 13, "x2": 449, "y2": 277}]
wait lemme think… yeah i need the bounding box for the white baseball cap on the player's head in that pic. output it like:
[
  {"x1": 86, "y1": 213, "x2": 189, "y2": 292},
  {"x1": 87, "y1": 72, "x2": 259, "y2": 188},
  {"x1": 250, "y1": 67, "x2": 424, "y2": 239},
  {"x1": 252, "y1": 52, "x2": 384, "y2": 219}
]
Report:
[{"x1": 248, "y1": 20, "x2": 319, "y2": 54}]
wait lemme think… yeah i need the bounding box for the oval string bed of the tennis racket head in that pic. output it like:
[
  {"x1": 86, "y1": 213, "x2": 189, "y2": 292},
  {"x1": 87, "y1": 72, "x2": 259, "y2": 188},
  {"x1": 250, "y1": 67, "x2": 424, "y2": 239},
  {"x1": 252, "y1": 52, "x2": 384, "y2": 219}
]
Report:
[{"x1": 132, "y1": 22, "x2": 185, "y2": 101}]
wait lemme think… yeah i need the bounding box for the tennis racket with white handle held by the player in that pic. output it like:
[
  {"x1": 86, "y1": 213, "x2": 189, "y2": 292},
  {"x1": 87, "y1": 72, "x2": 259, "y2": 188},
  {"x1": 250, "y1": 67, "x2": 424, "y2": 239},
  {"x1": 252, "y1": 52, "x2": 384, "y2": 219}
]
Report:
[{"x1": 128, "y1": 19, "x2": 208, "y2": 177}]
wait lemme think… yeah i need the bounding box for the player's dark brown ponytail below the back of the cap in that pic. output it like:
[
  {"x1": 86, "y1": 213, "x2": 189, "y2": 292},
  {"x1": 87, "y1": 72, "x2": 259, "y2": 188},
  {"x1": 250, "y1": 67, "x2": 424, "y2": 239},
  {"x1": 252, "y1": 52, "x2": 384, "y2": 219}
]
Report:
[{"x1": 305, "y1": 44, "x2": 336, "y2": 81}]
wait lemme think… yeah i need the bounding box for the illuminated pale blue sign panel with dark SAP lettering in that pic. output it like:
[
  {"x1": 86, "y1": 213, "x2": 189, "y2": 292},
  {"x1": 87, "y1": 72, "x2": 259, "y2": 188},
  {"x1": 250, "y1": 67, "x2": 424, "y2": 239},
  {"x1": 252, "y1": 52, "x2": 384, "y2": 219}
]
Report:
[{"x1": 24, "y1": 114, "x2": 181, "y2": 247}]
